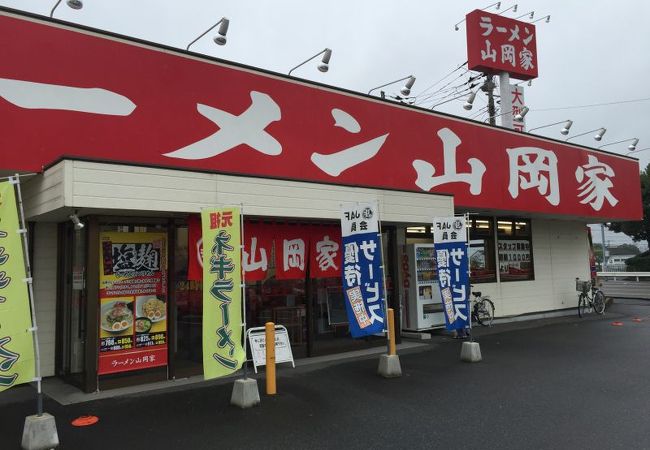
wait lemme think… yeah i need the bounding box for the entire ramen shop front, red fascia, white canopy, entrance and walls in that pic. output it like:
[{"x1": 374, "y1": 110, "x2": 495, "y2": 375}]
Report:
[{"x1": 0, "y1": 9, "x2": 641, "y2": 391}]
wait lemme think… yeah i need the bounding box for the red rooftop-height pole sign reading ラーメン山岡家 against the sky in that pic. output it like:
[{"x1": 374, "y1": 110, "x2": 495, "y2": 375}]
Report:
[{"x1": 465, "y1": 9, "x2": 537, "y2": 80}]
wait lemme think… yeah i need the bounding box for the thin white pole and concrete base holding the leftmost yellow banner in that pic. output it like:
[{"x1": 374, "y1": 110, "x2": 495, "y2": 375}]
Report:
[{"x1": 9, "y1": 174, "x2": 59, "y2": 449}]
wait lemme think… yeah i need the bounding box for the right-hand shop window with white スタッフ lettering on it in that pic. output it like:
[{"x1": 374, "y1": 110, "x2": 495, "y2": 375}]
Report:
[{"x1": 497, "y1": 218, "x2": 535, "y2": 281}]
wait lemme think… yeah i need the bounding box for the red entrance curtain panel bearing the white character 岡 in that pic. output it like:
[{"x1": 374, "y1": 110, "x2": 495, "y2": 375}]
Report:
[{"x1": 273, "y1": 225, "x2": 309, "y2": 280}]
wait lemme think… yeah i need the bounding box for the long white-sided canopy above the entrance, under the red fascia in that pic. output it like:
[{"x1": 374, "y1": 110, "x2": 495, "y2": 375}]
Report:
[{"x1": 22, "y1": 160, "x2": 453, "y2": 224}]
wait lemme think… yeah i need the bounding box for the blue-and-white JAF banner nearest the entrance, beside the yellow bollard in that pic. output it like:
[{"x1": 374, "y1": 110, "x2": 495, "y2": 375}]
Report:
[{"x1": 341, "y1": 202, "x2": 386, "y2": 338}]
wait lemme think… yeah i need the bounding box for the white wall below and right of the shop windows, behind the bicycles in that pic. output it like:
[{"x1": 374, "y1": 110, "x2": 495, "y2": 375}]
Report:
[{"x1": 466, "y1": 219, "x2": 589, "y2": 317}]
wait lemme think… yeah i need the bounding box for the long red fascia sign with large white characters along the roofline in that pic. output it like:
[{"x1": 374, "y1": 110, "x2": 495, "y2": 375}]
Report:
[{"x1": 0, "y1": 9, "x2": 642, "y2": 220}]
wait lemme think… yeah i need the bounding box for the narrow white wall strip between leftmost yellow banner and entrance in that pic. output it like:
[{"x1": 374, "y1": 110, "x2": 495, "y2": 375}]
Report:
[{"x1": 32, "y1": 222, "x2": 58, "y2": 377}]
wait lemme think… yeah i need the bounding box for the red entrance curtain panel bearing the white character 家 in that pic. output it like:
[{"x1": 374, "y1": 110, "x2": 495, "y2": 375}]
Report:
[{"x1": 309, "y1": 226, "x2": 342, "y2": 278}]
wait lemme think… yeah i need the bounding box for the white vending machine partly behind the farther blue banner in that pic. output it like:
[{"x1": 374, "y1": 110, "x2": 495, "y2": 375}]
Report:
[{"x1": 402, "y1": 244, "x2": 445, "y2": 331}]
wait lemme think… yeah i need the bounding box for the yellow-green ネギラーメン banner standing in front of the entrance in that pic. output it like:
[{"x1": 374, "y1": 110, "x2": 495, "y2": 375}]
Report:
[{"x1": 201, "y1": 208, "x2": 246, "y2": 379}]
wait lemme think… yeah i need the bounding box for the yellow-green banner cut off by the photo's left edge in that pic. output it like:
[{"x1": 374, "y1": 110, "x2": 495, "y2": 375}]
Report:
[{"x1": 0, "y1": 182, "x2": 35, "y2": 391}]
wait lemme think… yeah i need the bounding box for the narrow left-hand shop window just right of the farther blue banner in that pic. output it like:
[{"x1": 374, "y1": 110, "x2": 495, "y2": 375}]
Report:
[{"x1": 469, "y1": 217, "x2": 496, "y2": 283}]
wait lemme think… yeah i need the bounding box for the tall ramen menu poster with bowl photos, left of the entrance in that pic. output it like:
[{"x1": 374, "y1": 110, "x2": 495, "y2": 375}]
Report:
[{"x1": 98, "y1": 232, "x2": 167, "y2": 375}]
